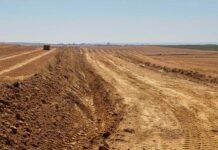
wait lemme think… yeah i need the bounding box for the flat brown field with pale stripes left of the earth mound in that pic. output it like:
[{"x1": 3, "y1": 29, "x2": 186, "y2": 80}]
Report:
[{"x1": 0, "y1": 45, "x2": 56, "y2": 82}]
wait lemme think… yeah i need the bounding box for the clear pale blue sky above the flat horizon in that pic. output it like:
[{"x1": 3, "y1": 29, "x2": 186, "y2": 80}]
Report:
[{"x1": 0, "y1": 0, "x2": 218, "y2": 44}]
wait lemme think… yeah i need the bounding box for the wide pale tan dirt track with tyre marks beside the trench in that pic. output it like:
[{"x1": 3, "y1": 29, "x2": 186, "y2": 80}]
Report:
[{"x1": 87, "y1": 50, "x2": 218, "y2": 150}]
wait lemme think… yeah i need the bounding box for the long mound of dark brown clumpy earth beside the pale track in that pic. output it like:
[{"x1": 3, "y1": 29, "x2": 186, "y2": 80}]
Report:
[{"x1": 0, "y1": 49, "x2": 122, "y2": 150}]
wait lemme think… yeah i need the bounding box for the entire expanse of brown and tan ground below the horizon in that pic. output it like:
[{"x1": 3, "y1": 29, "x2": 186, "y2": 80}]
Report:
[{"x1": 0, "y1": 46, "x2": 218, "y2": 150}]
